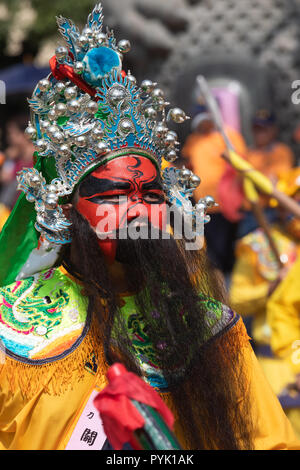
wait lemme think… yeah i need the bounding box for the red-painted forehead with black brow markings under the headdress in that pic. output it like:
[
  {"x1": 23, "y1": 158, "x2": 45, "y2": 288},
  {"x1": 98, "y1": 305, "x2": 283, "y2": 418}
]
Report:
[{"x1": 79, "y1": 156, "x2": 162, "y2": 197}]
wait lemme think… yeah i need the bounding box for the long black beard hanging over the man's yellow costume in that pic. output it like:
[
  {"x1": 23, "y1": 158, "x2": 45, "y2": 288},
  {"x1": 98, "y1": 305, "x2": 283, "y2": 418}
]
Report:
[{"x1": 64, "y1": 210, "x2": 252, "y2": 449}]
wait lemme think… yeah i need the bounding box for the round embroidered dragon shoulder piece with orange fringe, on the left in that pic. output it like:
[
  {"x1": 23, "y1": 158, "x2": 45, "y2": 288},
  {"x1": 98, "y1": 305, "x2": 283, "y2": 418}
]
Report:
[{"x1": 0, "y1": 268, "x2": 88, "y2": 364}]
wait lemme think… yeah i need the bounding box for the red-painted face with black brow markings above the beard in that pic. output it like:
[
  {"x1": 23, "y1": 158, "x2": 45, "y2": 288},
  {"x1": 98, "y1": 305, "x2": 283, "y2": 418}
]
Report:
[{"x1": 76, "y1": 155, "x2": 166, "y2": 262}]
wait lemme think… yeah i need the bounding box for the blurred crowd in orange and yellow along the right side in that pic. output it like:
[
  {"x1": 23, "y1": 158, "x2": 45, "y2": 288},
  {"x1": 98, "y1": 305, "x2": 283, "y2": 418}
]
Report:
[{"x1": 182, "y1": 99, "x2": 300, "y2": 436}]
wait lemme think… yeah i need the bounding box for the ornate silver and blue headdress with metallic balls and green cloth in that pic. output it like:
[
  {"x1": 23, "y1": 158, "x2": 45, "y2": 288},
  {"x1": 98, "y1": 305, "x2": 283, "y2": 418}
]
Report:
[{"x1": 0, "y1": 4, "x2": 213, "y2": 284}]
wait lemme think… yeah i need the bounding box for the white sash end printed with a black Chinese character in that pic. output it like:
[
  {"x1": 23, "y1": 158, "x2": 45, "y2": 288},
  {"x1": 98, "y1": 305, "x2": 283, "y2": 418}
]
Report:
[{"x1": 65, "y1": 390, "x2": 107, "y2": 450}]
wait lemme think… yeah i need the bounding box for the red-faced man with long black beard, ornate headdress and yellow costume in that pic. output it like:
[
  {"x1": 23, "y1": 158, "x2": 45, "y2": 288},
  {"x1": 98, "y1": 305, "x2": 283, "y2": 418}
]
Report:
[{"x1": 0, "y1": 5, "x2": 299, "y2": 450}]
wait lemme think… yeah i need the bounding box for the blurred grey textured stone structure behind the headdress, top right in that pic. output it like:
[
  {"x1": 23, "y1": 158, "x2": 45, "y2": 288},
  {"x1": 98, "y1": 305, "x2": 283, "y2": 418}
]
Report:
[{"x1": 103, "y1": 0, "x2": 300, "y2": 154}]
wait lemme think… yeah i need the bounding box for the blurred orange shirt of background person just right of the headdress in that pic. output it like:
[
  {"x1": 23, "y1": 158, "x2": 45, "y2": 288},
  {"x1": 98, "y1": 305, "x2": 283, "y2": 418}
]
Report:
[{"x1": 182, "y1": 128, "x2": 246, "y2": 202}]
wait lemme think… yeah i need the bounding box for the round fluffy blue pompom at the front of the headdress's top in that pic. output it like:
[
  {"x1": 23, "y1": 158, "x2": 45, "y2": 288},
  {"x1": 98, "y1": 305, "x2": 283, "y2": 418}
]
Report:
[{"x1": 83, "y1": 47, "x2": 122, "y2": 86}]
